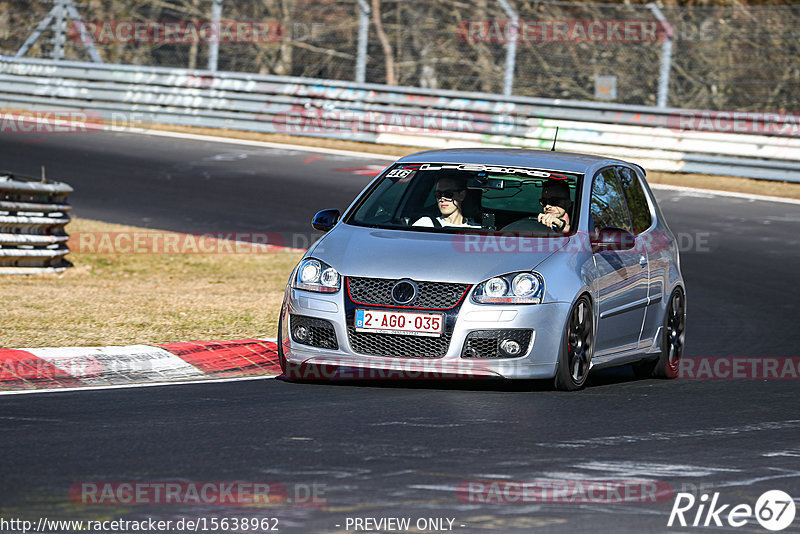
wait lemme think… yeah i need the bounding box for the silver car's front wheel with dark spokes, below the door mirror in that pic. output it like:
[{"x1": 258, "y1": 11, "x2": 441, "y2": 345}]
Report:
[{"x1": 554, "y1": 295, "x2": 594, "y2": 391}]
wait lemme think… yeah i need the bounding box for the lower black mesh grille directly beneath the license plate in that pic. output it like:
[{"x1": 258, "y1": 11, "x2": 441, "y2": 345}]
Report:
[{"x1": 347, "y1": 325, "x2": 452, "y2": 358}]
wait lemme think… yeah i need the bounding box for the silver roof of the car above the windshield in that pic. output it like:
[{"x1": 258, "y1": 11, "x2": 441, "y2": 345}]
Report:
[{"x1": 398, "y1": 148, "x2": 630, "y2": 173}]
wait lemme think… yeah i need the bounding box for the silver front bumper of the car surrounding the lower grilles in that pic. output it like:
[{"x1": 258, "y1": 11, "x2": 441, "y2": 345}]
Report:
[{"x1": 278, "y1": 287, "x2": 570, "y2": 379}]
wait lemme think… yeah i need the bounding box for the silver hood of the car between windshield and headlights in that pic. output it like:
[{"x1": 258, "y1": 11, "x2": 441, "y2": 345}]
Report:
[{"x1": 308, "y1": 223, "x2": 569, "y2": 284}]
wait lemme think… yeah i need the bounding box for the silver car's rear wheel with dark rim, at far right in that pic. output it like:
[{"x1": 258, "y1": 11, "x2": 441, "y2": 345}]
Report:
[{"x1": 633, "y1": 287, "x2": 686, "y2": 378}]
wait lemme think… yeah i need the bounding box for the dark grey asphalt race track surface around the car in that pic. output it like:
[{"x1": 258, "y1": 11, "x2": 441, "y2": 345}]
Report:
[{"x1": 0, "y1": 133, "x2": 800, "y2": 533}]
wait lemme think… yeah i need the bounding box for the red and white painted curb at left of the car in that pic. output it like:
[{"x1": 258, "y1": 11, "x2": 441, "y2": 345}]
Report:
[{"x1": 0, "y1": 339, "x2": 281, "y2": 391}]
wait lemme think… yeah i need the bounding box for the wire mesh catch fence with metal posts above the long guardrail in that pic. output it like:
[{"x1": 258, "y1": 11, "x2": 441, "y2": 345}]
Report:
[{"x1": 0, "y1": 0, "x2": 800, "y2": 111}]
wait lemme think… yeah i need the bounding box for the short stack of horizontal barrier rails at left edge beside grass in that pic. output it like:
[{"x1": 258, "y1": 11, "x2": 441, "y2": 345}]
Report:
[{"x1": 0, "y1": 171, "x2": 72, "y2": 274}]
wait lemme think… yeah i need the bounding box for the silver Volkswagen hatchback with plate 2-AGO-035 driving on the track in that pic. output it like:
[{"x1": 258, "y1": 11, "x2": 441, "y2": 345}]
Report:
[{"x1": 278, "y1": 149, "x2": 686, "y2": 390}]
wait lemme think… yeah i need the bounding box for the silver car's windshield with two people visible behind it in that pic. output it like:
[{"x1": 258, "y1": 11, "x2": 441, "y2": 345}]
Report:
[{"x1": 345, "y1": 163, "x2": 583, "y2": 237}]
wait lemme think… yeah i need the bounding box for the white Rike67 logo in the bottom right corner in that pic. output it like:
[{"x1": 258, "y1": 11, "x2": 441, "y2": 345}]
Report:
[{"x1": 667, "y1": 490, "x2": 796, "y2": 531}]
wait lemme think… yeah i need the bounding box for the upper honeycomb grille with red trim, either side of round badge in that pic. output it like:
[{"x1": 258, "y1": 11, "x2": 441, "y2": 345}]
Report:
[{"x1": 347, "y1": 277, "x2": 469, "y2": 310}]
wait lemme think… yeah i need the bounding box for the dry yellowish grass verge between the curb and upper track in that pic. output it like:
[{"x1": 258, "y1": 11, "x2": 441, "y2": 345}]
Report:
[{"x1": 0, "y1": 219, "x2": 302, "y2": 348}]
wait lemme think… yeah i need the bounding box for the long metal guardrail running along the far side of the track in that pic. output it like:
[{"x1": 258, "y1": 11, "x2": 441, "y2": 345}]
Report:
[{"x1": 0, "y1": 58, "x2": 800, "y2": 182}]
